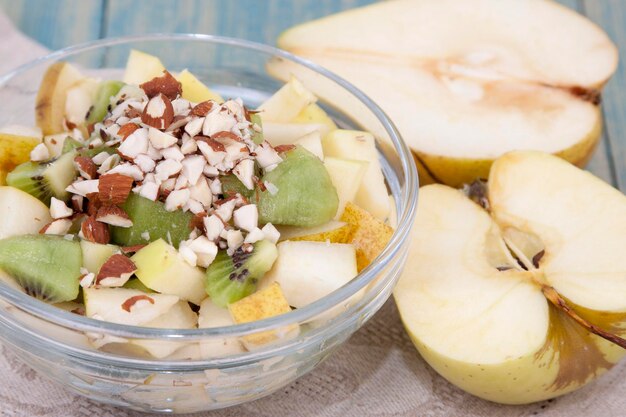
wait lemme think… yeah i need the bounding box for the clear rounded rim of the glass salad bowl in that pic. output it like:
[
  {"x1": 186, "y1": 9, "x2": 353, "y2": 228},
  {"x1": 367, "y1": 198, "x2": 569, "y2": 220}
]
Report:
[{"x1": 0, "y1": 33, "x2": 418, "y2": 340}]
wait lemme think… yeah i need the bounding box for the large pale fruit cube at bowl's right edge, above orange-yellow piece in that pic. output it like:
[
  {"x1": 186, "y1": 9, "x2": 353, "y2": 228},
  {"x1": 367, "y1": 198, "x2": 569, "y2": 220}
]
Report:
[{"x1": 323, "y1": 130, "x2": 389, "y2": 221}]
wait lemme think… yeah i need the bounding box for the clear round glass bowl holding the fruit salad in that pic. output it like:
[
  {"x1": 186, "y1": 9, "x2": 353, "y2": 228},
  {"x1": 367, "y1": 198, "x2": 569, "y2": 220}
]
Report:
[{"x1": 0, "y1": 34, "x2": 418, "y2": 413}]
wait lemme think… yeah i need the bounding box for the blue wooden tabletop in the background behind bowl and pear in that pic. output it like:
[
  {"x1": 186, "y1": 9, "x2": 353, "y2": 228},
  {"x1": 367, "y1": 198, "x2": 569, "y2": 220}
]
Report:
[{"x1": 0, "y1": 0, "x2": 626, "y2": 190}]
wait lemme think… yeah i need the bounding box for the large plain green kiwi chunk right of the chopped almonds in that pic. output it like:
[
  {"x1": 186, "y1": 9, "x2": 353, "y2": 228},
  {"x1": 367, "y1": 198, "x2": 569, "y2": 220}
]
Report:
[{"x1": 258, "y1": 146, "x2": 339, "y2": 227}]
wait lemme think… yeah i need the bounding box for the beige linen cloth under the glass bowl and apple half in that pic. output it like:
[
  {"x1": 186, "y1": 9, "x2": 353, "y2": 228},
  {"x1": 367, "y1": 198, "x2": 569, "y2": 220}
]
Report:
[{"x1": 0, "y1": 12, "x2": 626, "y2": 417}]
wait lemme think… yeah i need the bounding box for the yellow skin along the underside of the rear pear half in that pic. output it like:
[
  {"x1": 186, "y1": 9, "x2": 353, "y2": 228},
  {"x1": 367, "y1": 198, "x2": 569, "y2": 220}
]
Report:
[{"x1": 413, "y1": 107, "x2": 602, "y2": 188}]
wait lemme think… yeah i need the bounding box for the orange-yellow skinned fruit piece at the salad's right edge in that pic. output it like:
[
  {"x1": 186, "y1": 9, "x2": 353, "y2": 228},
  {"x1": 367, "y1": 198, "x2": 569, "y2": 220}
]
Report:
[{"x1": 341, "y1": 203, "x2": 393, "y2": 272}]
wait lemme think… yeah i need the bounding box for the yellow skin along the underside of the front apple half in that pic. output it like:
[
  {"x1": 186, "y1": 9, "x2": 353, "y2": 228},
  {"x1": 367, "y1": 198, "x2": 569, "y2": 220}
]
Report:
[{"x1": 405, "y1": 326, "x2": 625, "y2": 404}]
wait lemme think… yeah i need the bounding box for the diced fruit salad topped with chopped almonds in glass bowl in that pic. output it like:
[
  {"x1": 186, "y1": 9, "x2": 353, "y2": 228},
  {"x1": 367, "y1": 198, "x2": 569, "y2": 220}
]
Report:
[{"x1": 0, "y1": 51, "x2": 393, "y2": 358}]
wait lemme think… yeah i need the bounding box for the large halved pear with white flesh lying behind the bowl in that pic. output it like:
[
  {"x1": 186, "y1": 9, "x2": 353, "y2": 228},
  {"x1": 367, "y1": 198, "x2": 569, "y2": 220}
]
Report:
[{"x1": 270, "y1": 0, "x2": 618, "y2": 186}]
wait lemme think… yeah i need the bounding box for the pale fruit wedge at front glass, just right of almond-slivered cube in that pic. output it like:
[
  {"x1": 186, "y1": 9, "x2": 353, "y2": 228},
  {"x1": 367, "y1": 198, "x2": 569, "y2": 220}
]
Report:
[{"x1": 131, "y1": 300, "x2": 198, "y2": 359}]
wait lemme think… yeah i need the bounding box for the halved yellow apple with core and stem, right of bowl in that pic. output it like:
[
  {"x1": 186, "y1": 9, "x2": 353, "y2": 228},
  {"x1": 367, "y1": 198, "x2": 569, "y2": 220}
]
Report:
[{"x1": 394, "y1": 151, "x2": 626, "y2": 404}]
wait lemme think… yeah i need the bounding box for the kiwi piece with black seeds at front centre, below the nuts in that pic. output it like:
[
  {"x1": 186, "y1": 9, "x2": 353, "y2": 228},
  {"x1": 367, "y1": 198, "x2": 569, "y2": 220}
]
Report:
[{"x1": 205, "y1": 240, "x2": 278, "y2": 307}]
